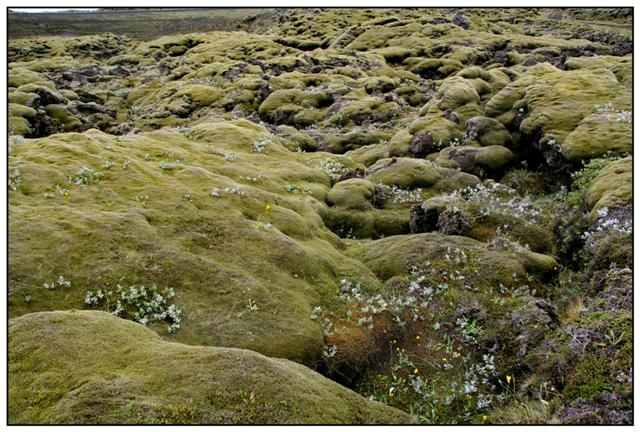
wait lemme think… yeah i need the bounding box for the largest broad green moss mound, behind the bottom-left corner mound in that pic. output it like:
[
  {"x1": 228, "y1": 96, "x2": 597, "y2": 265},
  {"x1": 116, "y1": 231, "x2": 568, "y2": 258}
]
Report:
[{"x1": 9, "y1": 120, "x2": 370, "y2": 364}]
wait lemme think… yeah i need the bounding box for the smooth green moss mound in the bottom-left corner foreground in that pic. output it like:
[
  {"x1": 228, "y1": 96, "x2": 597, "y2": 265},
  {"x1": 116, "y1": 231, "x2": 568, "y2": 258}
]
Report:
[{"x1": 9, "y1": 311, "x2": 409, "y2": 424}]
